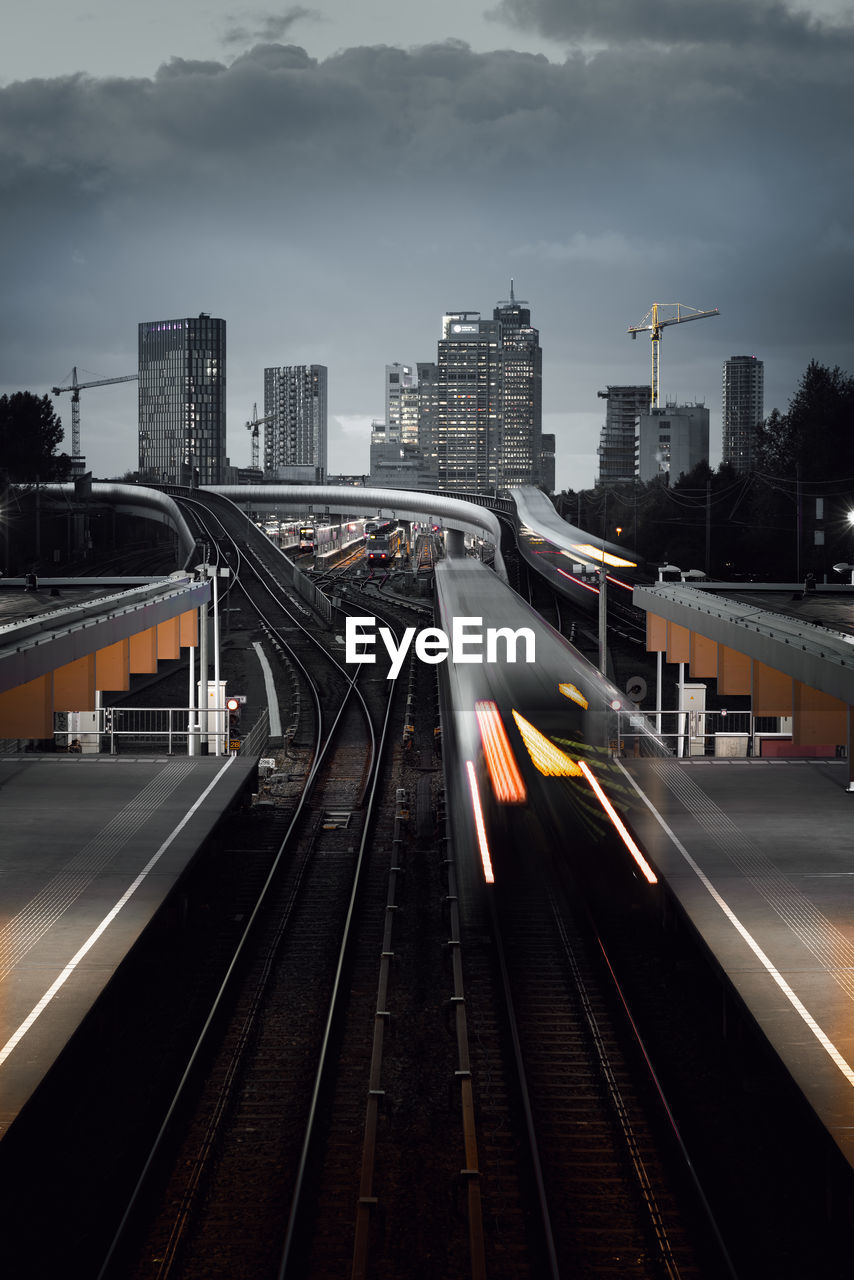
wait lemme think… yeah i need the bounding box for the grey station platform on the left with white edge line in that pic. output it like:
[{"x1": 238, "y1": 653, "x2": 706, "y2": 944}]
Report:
[{"x1": 0, "y1": 755, "x2": 257, "y2": 1142}]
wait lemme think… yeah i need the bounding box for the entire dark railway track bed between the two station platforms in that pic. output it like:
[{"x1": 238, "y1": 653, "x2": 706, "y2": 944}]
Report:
[{"x1": 6, "y1": 495, "x2": 788, "y2": 1280}]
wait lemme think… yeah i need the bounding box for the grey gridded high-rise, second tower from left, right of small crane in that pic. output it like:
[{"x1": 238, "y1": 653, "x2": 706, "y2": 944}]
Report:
[{"x1": 264, "y1": 365, "x2": 326, "y2": 484}]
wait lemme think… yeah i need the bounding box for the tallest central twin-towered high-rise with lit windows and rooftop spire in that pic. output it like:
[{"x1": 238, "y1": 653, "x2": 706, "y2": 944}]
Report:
[{"x1": 437, "y1": 290, "x2": 543, "y2": 492}]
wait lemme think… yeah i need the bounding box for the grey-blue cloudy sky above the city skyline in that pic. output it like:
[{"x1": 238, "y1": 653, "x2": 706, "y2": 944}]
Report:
[{"x1": 0, "y1": 0, "x2": 854, "y2": 488}]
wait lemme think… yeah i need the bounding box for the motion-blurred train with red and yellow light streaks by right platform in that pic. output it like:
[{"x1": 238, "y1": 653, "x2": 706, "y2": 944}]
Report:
[{"x1": 435, "y1": 559, "x2": 666, "y2": 882}]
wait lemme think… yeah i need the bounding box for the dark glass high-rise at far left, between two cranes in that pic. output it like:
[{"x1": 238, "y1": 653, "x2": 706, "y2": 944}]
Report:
[{"x1": 140, "y1": 312, "x2": 227, "y2": 484}]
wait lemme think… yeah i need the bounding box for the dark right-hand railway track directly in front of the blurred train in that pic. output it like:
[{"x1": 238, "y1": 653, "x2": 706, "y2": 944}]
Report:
[{"x1": 450, "y1": 849, "x2": 727, "y2": 1280}]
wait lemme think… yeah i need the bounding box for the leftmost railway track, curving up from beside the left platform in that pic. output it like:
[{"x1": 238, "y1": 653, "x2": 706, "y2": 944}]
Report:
[{"x1": 92, "y1": 496, "x2": 393, "y2": 1276}]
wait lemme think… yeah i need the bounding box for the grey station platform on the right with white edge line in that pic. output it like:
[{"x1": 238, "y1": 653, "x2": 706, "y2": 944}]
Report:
[{"x1": 620, "y1": 758, "x2": 854, "y2": 1166}]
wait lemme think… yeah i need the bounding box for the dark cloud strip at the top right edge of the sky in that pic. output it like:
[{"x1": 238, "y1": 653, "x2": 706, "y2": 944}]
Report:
[{"x1": 489, "y1": 0, "x2": 851, "y2": 49}]
